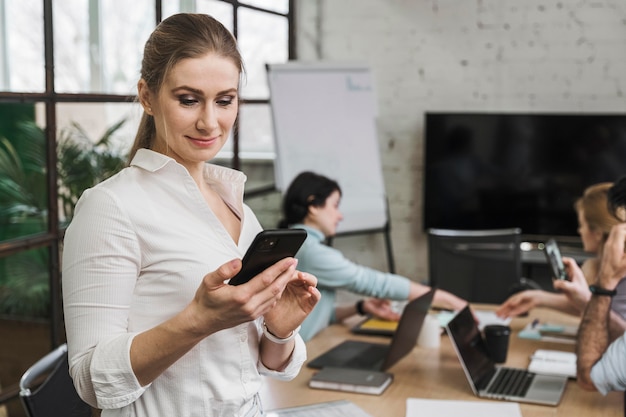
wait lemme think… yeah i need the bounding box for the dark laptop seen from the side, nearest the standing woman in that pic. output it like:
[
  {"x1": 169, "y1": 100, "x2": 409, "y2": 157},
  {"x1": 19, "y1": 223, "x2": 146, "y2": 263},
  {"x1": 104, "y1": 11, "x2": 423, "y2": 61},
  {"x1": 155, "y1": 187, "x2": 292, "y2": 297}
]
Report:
[{"x1": 307, "y1": 289, "x2": 435, "y2": 371}]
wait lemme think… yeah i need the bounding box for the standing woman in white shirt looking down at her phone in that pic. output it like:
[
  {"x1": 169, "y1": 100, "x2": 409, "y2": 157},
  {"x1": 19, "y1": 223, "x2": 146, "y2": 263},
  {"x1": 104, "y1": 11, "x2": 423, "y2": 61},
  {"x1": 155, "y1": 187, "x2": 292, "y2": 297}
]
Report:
[{"x1": 63, "y1": 14, "x2": 320, "y2": 417}]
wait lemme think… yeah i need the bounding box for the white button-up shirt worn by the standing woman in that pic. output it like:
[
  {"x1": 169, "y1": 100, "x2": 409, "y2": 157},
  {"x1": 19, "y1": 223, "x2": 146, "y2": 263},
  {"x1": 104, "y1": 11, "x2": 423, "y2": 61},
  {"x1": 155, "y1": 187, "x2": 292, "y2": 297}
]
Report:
[{"x1": 63, "y1": 149, "x2": 306, "y2": 417}]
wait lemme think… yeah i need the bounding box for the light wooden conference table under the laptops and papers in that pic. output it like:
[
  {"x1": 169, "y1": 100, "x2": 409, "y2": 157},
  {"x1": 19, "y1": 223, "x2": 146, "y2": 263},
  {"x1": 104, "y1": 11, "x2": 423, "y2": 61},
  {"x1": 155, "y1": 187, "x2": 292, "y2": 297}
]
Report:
[{"x1": 261, "y1": 305, "x2": 624, "y2": 417}]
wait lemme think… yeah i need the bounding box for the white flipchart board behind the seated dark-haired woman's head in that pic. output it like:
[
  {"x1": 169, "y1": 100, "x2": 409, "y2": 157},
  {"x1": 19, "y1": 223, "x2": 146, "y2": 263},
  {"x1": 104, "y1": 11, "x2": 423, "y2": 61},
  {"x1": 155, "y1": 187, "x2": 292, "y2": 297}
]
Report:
[{"x1": 267, "y1": 62, "x2": 387, "y2": 233}]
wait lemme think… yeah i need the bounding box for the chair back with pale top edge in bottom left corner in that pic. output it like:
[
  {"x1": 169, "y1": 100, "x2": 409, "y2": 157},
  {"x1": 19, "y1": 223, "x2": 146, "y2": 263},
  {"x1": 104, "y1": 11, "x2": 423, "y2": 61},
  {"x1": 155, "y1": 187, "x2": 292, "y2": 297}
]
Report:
[{"x1": 20, "y1": 344, "x2": 92, "y2": 417}]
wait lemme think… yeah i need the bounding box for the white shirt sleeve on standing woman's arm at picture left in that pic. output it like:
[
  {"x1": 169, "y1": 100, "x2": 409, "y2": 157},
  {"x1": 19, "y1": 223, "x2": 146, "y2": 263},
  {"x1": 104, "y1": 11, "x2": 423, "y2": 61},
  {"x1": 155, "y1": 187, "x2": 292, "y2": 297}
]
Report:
[{"x1": 63, "y1": 190, "x2": 144, "y2": 408}]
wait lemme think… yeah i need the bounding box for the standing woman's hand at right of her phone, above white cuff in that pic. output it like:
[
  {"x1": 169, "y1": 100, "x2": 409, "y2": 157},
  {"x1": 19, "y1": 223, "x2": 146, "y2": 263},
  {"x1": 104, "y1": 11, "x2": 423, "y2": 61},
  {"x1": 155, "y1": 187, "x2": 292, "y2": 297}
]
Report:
[{"x1": 264, "y1": 271, "x2": 322, "y2": 338}]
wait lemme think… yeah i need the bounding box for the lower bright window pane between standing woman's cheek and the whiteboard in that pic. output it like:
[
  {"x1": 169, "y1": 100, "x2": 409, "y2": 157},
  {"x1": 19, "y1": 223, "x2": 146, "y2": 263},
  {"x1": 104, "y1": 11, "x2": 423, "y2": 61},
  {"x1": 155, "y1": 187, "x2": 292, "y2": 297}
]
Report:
[{"x1": 239, "y1": 104, "x2": 274, "y2": 159}]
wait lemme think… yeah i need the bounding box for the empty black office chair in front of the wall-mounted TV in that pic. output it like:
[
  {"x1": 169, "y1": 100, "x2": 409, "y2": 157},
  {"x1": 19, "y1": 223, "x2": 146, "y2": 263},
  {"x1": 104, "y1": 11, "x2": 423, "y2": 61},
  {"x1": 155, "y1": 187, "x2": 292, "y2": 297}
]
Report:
[{"x1": 428, "y1": 228, "x2": 525, "y2": 304}]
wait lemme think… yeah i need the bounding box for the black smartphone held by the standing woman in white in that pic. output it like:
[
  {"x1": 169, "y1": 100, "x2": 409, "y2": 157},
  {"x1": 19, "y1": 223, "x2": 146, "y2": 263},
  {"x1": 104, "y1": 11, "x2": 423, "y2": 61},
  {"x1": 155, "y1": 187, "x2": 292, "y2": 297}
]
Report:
[{"x1": 228, "y1": 229, "x2": 306, "y2": 285}]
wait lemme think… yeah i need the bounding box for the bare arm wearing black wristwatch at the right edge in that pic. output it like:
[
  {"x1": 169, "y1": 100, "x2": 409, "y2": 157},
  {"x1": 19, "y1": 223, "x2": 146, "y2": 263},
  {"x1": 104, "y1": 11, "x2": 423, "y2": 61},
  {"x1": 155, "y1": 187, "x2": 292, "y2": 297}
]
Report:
[{"x1": 576, "y1": 224, "x2": 626, "y2": 390}]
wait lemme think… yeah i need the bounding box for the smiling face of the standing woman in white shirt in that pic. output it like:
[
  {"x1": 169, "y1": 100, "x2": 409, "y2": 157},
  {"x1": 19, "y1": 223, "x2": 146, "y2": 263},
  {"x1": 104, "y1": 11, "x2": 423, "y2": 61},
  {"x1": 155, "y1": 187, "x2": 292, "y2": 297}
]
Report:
[{"x1": 139, "y1": 53, "x2": 239, "y2": 169}]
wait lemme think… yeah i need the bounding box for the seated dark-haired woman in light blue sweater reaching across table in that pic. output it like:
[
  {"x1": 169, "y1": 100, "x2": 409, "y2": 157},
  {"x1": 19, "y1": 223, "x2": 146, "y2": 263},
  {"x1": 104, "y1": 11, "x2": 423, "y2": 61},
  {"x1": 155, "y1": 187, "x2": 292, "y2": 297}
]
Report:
[{"x1": 280, "y1": 172, "x2": 467, "y2": 341}]
